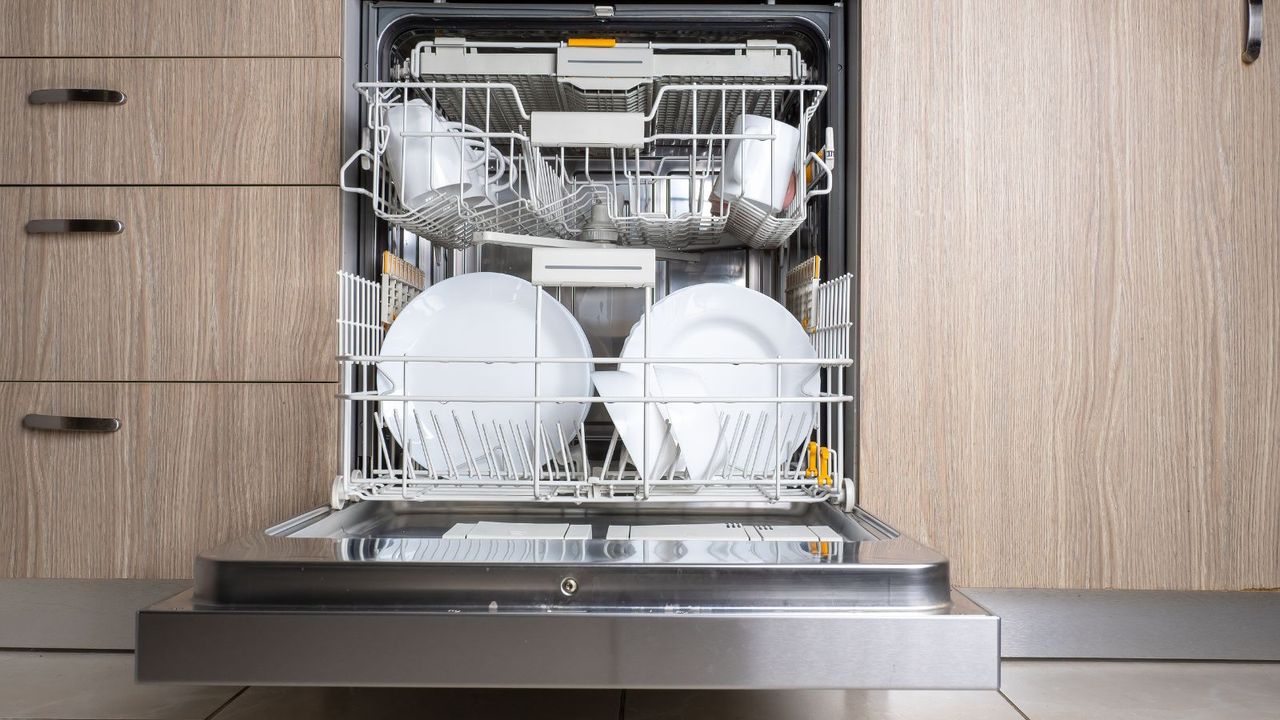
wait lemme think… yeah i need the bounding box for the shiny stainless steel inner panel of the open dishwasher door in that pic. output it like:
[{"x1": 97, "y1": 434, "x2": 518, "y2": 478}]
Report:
[{"x1": 195, "y1": 502, "x2": 950, "y2": 612}]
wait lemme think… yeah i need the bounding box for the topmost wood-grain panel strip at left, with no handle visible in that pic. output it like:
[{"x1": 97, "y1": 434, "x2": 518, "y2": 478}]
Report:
[{"x1": 0, "y1": 0, "x2": 342, "y2": 58}]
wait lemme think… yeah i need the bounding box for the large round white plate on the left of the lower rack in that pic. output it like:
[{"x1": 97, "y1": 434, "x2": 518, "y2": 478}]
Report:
[{"x1": 378, "y1": 273, "x2": 591, "y2": 475}]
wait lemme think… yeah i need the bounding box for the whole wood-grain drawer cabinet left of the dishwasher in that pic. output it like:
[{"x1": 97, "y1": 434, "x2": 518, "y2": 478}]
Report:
[{"x1": 0, "y1": 0, "x2": 344, "y2": 586}]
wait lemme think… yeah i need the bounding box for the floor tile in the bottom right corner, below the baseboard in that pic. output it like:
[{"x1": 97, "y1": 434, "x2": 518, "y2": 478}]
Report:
[{"x1": 1001, "y1": 660, "x2": 1280, "y2": 720}]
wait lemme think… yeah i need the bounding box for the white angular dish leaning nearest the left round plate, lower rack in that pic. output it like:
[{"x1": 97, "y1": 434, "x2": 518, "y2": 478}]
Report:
[{"x1": 591, "y1": 370, "x2": 678, "y2": 480}]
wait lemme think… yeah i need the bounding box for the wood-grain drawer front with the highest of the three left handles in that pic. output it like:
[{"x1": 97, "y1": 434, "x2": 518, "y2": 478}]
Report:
[{"x1": 0, "y1": 58, "x2": 342, "y2": 184}]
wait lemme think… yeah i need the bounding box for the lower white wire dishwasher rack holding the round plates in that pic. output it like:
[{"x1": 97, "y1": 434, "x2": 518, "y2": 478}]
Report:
[{"x1": 334, "y1": 266, "x2": 852, "y2": 503}]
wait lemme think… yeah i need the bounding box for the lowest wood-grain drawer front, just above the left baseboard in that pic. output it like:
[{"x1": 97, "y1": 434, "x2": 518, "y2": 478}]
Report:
[{"x1": 0, "y1": 383, "x2": 337, "y2": 578}]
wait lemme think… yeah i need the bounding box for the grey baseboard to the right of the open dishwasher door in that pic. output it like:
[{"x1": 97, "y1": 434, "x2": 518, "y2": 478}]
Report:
[{"x1": 963, "y1": 588, "x2": 1280, "y2": 661}]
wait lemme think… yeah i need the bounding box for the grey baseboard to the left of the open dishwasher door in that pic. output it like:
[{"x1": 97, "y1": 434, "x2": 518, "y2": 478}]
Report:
[{"x1": 0, "y1": 579, "x2": 191, "y2": 650}]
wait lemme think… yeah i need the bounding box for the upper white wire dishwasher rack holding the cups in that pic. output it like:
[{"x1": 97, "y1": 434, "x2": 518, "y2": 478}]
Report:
[{"x1": 340, "y1": 81, "x2": 835, "y2": 250}]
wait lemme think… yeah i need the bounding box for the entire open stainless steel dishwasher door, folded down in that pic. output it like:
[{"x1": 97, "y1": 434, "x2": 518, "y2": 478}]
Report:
[{"x1": 137, "y1": 502, "x2": 1000, "y2": 688}]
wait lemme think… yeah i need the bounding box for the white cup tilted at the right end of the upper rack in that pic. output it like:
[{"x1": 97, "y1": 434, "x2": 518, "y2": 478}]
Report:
[{"x1": 716, "y1": 115, "x2": 800, "y2": 213}]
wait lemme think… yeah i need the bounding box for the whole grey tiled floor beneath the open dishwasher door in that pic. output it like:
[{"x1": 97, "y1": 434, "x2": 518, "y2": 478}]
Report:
[{"x1": 0, "y1": 651, "x2": 1280, "y2": 720}]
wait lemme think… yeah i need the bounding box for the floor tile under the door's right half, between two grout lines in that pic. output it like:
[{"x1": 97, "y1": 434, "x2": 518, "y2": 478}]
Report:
[{"x1": 623, "y1": 691, "x2": 1021, "y2": 720}]
